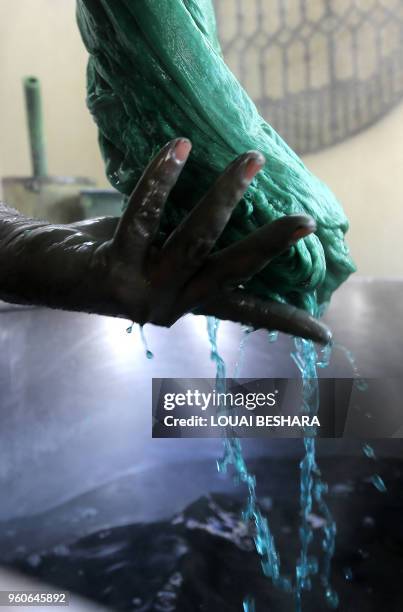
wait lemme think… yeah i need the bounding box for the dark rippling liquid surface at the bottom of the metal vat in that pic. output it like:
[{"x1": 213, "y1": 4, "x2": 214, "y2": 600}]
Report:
[{"x1": 1, "y1": 457, "x2": 403, "y2": 612}]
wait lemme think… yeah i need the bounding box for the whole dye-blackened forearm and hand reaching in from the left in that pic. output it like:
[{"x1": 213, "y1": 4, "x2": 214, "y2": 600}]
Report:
[{"x1": 0, "y1": 139, "x2": 330, "y2": 343}]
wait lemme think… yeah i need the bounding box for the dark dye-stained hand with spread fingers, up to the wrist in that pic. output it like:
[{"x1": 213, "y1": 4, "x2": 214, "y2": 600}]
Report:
[{"x1": 76, "y1": 139, "x2": 331, "y2": 343}]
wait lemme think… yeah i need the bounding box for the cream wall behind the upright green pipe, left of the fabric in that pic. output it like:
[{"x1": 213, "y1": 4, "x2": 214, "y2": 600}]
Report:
[{"x1": 0, "y1": 0, "x2": 107, "y2": 185}]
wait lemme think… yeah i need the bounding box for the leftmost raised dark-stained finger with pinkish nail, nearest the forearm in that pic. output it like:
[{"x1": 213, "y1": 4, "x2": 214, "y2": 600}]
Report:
[{"x1": 113, "y1": 138, "x2": 192, "y2": 267}]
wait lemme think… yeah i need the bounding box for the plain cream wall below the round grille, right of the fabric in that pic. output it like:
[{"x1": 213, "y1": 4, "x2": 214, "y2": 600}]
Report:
[{"x1": 304, "y1": 104, "x2": 403, "y2": 276}]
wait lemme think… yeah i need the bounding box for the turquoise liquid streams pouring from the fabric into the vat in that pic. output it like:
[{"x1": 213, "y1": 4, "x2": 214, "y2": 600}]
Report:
[{"x1": 207, "y1": 317, "x2": 339, "y2": 612}]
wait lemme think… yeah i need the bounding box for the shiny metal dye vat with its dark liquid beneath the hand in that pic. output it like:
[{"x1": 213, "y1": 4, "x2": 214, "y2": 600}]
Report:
[{"x1": 0, "y1": 280, "x2": 403, "y2": 612}]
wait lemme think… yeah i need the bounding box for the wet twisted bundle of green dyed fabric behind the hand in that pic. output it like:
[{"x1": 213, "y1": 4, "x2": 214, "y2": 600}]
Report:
[{"x1": 77, "y1": 0, "x2": 355, "y2": 308}]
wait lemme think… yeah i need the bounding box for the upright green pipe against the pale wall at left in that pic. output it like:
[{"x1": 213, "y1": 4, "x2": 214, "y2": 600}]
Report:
[{"x1": 23, "y1": 76, "x2": 48, "y2": 178}]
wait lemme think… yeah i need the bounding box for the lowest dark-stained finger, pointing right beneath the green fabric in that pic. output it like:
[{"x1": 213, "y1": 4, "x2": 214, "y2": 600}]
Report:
[{"x1": 202, "y1": 291, "x2": 332, "y2": 344}]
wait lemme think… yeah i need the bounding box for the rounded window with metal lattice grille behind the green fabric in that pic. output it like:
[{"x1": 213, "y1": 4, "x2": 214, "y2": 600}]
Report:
[{"x1": 215, "y1": 0, "x2": 403, "y2": 154}]
